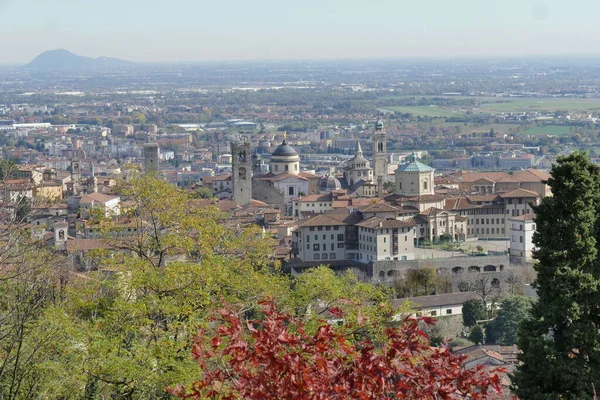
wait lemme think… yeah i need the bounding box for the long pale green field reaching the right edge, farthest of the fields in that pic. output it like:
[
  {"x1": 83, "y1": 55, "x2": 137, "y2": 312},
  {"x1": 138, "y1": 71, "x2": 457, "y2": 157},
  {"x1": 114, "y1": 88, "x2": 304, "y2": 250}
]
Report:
[{"x1": 480, "y1": 98, "x2": 600, "y2": 113}]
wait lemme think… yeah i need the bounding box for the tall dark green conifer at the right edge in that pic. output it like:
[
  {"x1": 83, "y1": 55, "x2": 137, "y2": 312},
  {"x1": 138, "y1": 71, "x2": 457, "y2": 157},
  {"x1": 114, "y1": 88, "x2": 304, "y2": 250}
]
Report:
[{"x1": 513, "y1": 152, "x2": 600, "y2": 399}]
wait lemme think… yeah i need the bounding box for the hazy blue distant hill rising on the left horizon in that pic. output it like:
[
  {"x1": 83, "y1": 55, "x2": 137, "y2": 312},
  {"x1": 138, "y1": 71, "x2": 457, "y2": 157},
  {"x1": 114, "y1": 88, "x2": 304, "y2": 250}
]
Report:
[{"x1": 24, "y1": 49, "x2": 135, "y2": 71}]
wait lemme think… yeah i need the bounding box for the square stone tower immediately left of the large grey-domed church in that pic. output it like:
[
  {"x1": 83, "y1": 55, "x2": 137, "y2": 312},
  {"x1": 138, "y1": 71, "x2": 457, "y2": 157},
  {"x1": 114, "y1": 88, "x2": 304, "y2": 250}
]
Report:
[{"x1": 231, "y1": 142, "x2": 253, "y2": 206}]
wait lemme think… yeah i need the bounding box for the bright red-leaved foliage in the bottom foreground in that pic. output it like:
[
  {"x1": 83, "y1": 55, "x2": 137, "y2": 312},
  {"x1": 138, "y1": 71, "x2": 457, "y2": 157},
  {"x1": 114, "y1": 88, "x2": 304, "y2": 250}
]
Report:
[{"x1": 168, "y1": 301, "x2": 502, "y2": 400}]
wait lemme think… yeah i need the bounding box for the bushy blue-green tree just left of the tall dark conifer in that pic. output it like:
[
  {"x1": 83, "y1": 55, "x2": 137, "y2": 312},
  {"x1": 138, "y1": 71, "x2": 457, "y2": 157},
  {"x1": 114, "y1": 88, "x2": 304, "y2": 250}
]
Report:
[{"x1": 486, "y1": 296, "x2": 534, "y2": 346}]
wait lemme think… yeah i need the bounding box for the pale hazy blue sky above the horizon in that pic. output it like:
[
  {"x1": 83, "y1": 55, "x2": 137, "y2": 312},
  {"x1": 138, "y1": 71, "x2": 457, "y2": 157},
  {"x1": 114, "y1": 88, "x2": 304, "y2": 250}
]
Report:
[{"x1": 0, "y1": 0, "x2": 600, "y2": 64}]
